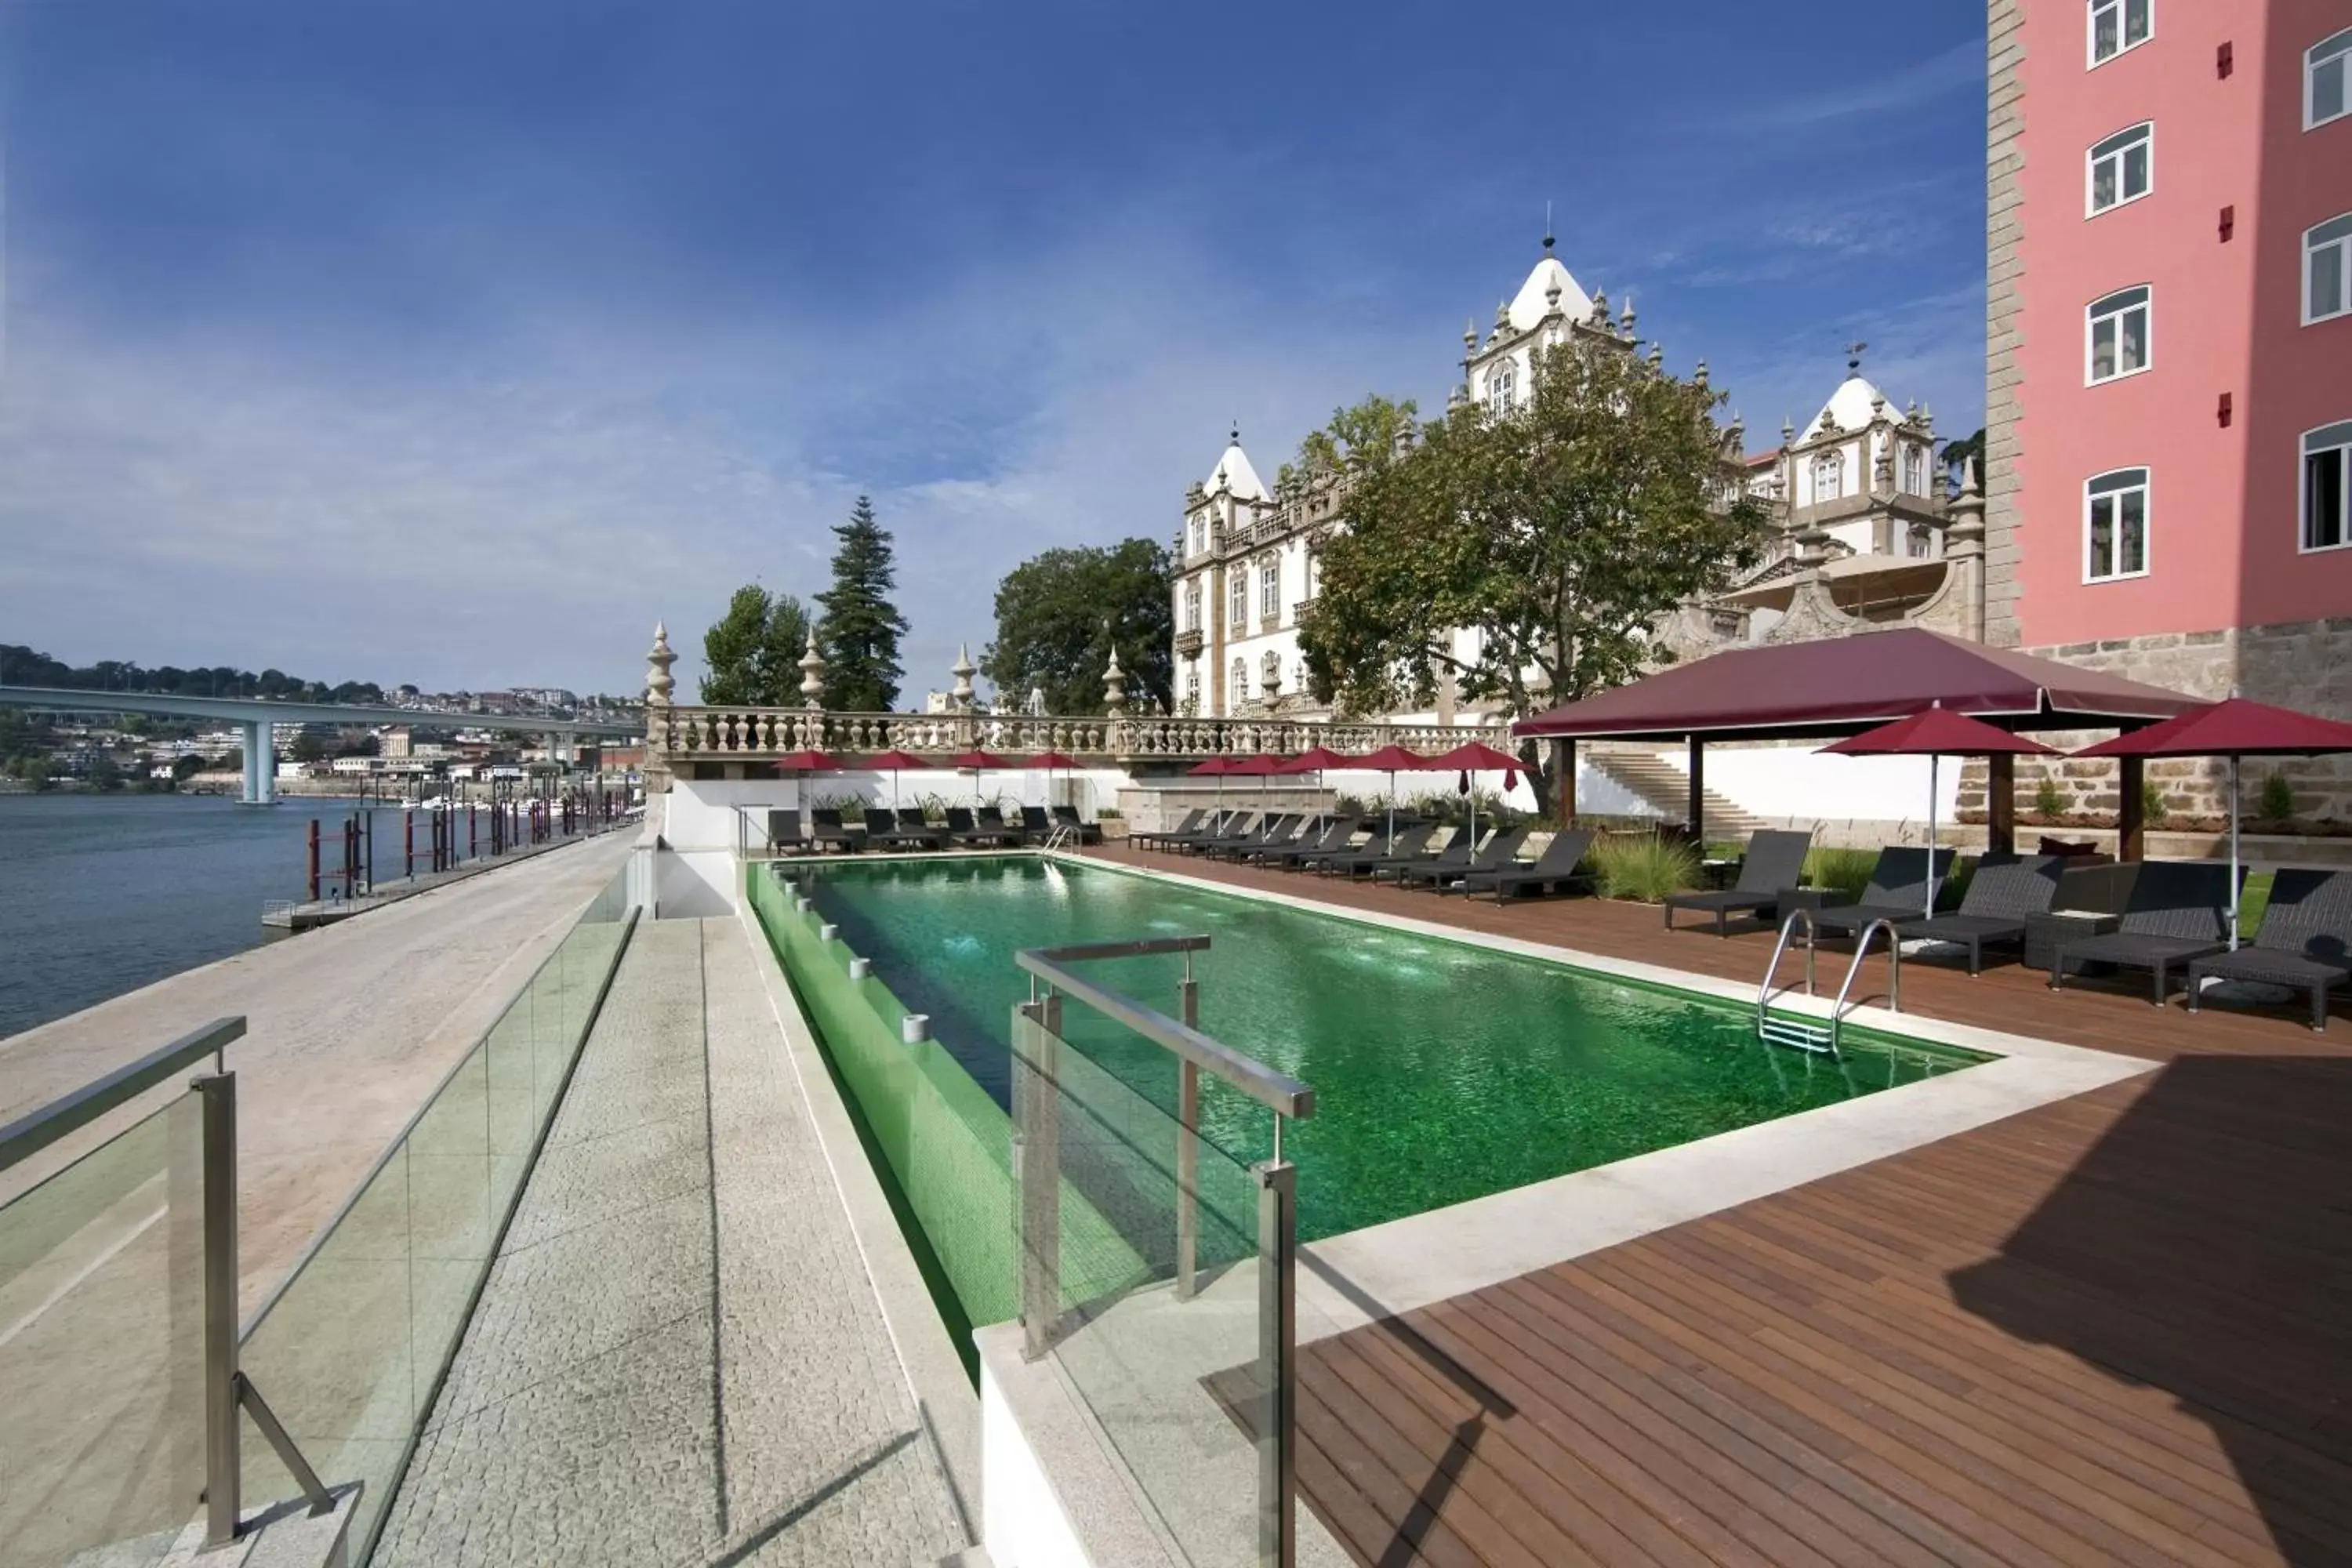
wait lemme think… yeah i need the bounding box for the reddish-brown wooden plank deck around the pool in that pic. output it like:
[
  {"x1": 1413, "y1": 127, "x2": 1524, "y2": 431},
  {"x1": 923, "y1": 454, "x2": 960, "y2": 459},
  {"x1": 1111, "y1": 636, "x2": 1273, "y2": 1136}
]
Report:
[{"x1": 1096, "y1": 846, "x2": 2352, "y2": 1568}]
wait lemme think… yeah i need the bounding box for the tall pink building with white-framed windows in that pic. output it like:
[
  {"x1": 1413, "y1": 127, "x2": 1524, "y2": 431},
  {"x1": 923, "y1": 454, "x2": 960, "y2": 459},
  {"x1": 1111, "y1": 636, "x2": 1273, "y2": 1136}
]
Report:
[{"x1": 1985, "y1": 0, "x2": 2352, "y2": 717}]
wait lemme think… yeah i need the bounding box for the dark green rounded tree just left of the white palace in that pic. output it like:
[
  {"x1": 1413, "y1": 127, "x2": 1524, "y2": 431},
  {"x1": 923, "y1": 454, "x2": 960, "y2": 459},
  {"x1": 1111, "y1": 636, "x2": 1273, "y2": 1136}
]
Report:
[{"x1": 981, "y1": 539, "x2": 1176, "y2": 713}]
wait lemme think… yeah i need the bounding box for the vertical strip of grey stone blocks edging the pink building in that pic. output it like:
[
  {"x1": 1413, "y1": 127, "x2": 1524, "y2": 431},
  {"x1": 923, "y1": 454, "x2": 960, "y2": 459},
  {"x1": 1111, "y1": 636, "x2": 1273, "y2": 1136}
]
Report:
[{"x1": 1983, "y1": 0, "x2": 2025, "y2": 647}]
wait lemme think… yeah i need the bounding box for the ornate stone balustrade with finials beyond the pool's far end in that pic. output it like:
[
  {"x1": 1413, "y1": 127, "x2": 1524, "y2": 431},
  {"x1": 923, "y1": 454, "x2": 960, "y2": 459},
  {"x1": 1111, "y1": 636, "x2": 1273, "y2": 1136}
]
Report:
[{"x1": 647, "y1": 706, "x2": 1510, "y2": 764}]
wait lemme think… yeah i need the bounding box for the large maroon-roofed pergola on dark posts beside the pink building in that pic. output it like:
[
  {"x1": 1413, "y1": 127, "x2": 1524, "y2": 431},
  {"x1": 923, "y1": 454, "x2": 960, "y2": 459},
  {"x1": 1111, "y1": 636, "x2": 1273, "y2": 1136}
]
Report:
[{"x1": 1512, "y1": 628, "x2": 2204, "y2": 860}]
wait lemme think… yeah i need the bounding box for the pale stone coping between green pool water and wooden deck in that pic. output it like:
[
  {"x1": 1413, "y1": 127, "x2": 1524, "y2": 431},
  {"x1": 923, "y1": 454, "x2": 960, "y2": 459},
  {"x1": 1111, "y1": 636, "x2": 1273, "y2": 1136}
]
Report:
[{"x1": 1042, "y1": 853, "x2": 2159, "y2": 1342}]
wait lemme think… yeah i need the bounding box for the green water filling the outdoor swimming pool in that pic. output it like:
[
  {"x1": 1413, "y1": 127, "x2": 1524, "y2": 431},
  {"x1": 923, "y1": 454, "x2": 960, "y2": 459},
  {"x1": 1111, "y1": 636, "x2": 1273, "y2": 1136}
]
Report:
[{"x1": 793, "y1": 855, "x2": 1983, "y2": 1250}]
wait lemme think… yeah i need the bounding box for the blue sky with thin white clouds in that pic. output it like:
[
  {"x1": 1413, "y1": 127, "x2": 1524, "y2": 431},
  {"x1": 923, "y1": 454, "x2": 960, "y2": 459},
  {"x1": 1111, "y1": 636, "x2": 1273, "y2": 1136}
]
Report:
[{"x1": 0, "y1": 0, "x2": 1985, "y2": 703}]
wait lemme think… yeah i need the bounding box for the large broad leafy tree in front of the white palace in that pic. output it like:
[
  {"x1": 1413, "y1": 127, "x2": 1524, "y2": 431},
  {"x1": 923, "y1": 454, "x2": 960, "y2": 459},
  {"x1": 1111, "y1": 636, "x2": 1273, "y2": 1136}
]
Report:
[{"x1": 1298, "y1": 339, "x2": 1766, "y2": 808}]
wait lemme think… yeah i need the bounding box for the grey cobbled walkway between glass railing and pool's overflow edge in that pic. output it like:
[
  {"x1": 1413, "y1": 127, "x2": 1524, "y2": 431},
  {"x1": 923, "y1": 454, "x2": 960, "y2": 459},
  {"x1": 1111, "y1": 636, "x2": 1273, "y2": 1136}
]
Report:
[{"x1": 374, "y1": 919, "x2": 964, "y2": 1568}]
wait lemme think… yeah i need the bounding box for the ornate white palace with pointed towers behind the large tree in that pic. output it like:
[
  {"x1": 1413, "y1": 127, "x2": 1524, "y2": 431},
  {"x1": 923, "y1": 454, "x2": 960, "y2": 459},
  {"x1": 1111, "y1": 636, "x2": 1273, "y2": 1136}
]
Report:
[{"x1": 1174, "y1": 238, "x2": 1973, "y2": 724}]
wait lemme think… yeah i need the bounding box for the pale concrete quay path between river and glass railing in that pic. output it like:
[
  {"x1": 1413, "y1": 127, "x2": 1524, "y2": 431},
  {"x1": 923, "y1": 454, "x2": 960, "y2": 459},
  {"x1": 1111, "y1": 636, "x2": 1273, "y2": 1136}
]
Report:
[{"x1": 0, "y1": 832, "x2": 635, "y2": 1312}]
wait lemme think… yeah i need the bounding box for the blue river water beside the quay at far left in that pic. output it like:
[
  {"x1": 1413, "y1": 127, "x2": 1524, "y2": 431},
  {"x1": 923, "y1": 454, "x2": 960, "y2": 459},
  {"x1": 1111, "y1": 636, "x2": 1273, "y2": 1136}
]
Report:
[{"x1": 0, "y1": 794, "x2": 426, "y2": 1036}]
